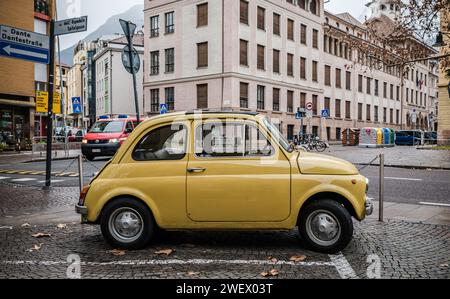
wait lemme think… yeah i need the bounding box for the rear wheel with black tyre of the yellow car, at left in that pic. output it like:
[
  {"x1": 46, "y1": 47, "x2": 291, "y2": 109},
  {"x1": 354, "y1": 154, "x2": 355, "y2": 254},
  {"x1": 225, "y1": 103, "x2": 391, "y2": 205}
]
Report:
[{"x1": 100, "y1": 198, "x2": 156, "y2": 250}]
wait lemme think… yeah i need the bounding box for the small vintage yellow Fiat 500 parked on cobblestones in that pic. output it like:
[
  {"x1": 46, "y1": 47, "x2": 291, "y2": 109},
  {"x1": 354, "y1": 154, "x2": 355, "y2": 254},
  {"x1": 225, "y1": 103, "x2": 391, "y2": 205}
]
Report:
[{"x1": 76, "y1": 112, "x2": 372, "y2": 253}]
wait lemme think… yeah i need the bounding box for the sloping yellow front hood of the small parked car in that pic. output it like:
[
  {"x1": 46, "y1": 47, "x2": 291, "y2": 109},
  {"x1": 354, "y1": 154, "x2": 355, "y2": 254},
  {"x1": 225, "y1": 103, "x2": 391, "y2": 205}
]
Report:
[{"x1": 297, "y1": 152, "x2": 359, "y2": 175}]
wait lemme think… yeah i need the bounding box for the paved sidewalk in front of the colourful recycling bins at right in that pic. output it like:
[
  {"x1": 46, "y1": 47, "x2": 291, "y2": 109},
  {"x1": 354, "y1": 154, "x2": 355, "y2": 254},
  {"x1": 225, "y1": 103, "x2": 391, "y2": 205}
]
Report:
[{"x1": 325, "y1": 145, "x2": 450, "y2": 170}]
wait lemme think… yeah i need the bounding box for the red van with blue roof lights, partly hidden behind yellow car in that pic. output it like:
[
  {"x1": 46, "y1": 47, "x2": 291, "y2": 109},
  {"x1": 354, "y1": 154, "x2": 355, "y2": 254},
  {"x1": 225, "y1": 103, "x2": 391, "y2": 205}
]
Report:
[{"x1": 81, "y1": 116, "x2": 138, "y2": 161}]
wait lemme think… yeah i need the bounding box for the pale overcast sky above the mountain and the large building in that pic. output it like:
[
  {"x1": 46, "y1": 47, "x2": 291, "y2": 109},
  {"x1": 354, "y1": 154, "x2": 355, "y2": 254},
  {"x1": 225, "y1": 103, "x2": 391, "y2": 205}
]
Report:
[{"x1": 57, "y1": 0, "x2": 368, "y2": 49}]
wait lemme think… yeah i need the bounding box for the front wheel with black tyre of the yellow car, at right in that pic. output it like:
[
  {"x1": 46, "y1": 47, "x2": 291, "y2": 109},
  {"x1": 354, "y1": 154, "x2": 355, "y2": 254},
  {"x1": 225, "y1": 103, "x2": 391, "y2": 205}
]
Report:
[{"x1": 298, "y1": 199, "x2": 353, "y2": 254}]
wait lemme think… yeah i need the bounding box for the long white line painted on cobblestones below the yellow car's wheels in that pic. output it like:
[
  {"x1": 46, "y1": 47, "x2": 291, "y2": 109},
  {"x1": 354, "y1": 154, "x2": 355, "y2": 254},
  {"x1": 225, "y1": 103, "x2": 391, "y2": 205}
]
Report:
[{"x1": 1, "y1": 259, "x2": 335, "y2": 267}]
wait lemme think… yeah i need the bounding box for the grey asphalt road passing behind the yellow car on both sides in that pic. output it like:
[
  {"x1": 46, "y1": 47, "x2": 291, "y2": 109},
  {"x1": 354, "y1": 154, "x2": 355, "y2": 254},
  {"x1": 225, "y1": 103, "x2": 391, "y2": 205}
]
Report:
[{"x1": 0, "y1": 158, "x2": 450, "y2": 204}]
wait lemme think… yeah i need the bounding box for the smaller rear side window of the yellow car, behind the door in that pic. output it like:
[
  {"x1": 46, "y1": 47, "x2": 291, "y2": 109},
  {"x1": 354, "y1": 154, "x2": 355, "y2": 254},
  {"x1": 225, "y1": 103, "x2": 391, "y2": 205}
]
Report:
[{"x1": 132, "y1": 124, "x2": 187, "y2": 161}]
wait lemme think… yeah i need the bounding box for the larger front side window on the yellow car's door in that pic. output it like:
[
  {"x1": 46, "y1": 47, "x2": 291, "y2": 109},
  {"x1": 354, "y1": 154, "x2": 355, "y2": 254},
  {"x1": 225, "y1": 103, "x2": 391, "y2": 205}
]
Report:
[{"x1": 195, "y1": 123, "x2": 274, "y2": 157}]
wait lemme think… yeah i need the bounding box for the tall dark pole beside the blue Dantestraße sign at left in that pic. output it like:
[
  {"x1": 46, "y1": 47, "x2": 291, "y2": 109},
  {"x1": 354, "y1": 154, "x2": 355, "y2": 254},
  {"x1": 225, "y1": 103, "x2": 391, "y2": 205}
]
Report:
[{"x1": 45, "y1": 20, "x2": 55, "y2": 188}]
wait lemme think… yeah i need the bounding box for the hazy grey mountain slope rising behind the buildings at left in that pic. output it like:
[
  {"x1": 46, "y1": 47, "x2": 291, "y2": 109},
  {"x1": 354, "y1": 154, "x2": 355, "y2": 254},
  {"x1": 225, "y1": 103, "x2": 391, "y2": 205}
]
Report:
[{"x1": 61, "y1": 5, "x2": 144, "y2": 65}]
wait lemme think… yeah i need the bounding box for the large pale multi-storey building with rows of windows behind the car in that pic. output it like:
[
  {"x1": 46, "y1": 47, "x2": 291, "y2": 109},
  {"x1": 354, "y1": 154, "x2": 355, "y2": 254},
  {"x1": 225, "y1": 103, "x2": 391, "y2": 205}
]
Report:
[{"x1": 144, "y1": 0, "x2": 436, "y2": 140}]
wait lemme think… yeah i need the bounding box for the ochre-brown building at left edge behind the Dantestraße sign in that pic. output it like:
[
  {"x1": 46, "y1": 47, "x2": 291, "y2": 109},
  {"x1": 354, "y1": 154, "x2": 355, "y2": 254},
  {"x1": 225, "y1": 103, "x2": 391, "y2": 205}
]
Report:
[{"x1": 0, "y1": 0, "x2": 55, "y2": 145}]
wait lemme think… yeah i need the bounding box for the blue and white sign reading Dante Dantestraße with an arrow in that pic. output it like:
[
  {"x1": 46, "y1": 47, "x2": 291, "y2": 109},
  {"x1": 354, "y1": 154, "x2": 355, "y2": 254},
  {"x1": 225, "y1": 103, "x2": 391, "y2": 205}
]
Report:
[{"x1": 0, "y1": 25, "x2": 50, "y2": 64}]
